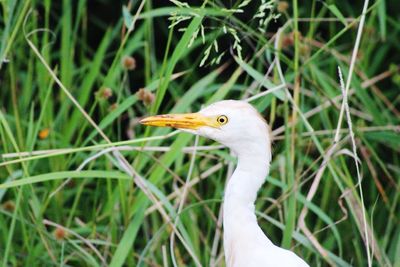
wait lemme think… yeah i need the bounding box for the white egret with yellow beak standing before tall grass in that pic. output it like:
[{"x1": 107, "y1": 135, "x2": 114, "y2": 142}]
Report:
[{"x1": 140, "y1": 100, "x2": 309, "y2": 267}]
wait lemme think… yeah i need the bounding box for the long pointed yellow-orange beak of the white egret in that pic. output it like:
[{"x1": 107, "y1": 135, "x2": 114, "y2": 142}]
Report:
[{"x1": 140, "y1": 113, "x2": 219, "y2": 130}]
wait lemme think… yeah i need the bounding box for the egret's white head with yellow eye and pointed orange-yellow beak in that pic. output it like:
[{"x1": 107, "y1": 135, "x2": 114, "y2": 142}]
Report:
[{"x1": 140, "y1": 100, "x2": 270, "y2": 154}]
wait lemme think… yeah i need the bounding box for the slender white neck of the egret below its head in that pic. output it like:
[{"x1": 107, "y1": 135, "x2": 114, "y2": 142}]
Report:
[{"x1": 224, "y1": 140, "x2": 273, "y2": 266}]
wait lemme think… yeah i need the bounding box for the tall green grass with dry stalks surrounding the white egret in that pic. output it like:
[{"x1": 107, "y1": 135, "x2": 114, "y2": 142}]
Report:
[{"x1": 0, "y1": 0, "x2": 400, "y2": 267}]
